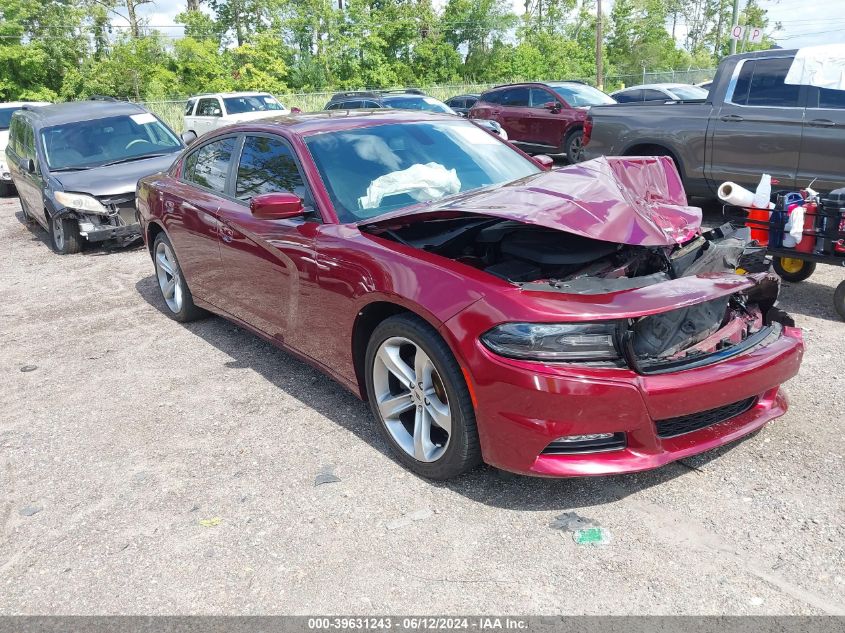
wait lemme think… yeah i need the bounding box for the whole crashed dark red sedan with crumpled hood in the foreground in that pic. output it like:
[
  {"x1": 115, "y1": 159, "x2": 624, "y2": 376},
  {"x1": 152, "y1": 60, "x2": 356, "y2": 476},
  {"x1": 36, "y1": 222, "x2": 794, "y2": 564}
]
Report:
[{"x1": 137, "y1": 111, "x2": 803, "y2": 478}]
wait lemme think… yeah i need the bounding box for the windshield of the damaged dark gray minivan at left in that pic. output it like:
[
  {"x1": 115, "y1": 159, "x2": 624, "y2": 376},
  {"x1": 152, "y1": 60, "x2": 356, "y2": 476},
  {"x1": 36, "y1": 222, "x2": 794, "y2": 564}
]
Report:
[{"x1": 41, "y1": 112, "x2": 182, "y2": 170}]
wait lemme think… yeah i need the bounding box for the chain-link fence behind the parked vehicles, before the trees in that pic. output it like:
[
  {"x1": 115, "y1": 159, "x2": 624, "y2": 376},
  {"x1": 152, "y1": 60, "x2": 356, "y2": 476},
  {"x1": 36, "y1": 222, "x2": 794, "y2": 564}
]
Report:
[{"x1": 139, "y1": 68, "x2": 716, "y2": 132}]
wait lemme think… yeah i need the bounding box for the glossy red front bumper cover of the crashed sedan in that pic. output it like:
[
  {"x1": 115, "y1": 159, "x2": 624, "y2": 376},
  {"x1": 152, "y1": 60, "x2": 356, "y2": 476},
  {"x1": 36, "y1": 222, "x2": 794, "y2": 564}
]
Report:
[{"x1": 458, "y1": 328, "x2": 803, "y2": 477}]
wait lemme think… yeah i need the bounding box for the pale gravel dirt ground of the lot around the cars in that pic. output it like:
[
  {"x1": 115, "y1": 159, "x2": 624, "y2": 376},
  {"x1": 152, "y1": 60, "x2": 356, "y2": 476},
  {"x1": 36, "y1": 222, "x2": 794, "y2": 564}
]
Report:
[{"x1": 0, "y1": 199, "x2": 845, "y2": 614}]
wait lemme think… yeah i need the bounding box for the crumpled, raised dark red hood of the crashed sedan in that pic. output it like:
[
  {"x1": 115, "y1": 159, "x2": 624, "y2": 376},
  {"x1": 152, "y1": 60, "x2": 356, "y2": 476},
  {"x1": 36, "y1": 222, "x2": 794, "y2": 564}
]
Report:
[{"x1": 362, "y1": 156, "x2": 701, "y2": 246}]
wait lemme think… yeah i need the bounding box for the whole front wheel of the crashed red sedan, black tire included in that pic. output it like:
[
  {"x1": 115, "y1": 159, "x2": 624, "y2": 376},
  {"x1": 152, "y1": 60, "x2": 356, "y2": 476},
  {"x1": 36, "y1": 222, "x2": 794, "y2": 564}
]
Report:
[{"x1": 364, "y1": 314, "x2": 481, "y2": 480}]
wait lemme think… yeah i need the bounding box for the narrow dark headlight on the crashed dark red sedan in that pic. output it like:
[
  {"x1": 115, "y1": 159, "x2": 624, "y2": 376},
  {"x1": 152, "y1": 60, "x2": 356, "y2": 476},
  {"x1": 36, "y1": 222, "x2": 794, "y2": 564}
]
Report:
[{"x1": 481, "y1": 323, "x2": 619, "y2": 361}]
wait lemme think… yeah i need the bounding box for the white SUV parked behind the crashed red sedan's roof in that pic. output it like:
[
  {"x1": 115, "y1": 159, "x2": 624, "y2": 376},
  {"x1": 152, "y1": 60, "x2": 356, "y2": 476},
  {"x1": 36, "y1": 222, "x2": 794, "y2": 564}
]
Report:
[{"x1": 182, "y1": 92, "x2": 290, "y2": 143}]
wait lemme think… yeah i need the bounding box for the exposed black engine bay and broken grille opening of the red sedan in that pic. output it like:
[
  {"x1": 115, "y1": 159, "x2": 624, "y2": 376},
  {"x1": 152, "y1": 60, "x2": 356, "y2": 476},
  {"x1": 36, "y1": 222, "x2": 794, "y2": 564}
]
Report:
[{"x1": 363, "y1": 214, "x2": 794, "y2": 373}]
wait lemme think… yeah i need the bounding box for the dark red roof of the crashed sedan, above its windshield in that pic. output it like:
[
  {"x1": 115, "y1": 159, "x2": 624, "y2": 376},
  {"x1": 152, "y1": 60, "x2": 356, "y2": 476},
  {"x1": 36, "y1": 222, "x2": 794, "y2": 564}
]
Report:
[{"x1": 209, "y1": 108, "x2": 462, "y2": 136}]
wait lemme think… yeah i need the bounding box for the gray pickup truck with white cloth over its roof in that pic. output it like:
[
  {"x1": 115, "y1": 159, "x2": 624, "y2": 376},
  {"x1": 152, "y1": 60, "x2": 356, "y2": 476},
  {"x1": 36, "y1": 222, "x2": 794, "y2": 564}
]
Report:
[{"x1": 584, "y1": 49, "x2": 845, "y2": 198}]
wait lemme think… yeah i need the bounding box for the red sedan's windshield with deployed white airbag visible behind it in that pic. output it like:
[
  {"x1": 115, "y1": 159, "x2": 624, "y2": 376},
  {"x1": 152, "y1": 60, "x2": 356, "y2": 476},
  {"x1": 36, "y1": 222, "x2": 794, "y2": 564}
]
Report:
[{"x1": 305, "y1": 120, "x2": 540, "y2": 222}]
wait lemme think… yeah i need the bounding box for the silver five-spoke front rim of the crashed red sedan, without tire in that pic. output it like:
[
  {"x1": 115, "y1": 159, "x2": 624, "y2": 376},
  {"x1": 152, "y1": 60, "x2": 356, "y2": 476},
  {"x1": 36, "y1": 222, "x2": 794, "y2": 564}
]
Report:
[{"x1": 372, "y1": 336, "x2": 452, "y2": 462}]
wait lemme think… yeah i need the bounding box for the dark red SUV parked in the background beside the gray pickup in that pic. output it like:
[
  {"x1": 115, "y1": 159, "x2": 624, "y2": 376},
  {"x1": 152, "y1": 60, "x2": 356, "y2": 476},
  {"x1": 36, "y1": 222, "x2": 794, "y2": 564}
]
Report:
[{"x1": 469, "y1": 81, "x2": 616, "y2": 163}]
